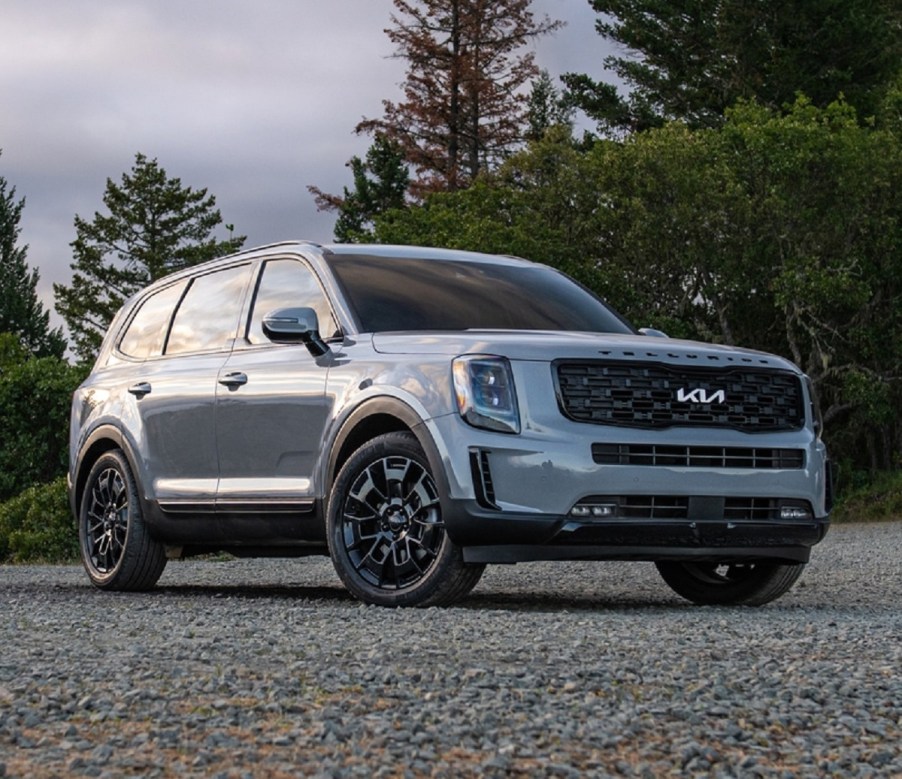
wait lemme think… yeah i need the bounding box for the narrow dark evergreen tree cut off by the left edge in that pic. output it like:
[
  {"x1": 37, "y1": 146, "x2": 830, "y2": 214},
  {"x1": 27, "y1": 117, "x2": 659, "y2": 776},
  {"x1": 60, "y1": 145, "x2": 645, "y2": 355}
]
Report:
[{"x1": 0, "y1": 153, "x2": 66, "y2": 357}]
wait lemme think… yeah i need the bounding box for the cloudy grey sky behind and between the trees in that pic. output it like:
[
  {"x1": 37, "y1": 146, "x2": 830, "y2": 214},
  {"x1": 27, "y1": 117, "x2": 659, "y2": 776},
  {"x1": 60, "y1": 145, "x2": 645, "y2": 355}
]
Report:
[{"x1": 0, "y1": 0, "x2": 605, "y2": 324}]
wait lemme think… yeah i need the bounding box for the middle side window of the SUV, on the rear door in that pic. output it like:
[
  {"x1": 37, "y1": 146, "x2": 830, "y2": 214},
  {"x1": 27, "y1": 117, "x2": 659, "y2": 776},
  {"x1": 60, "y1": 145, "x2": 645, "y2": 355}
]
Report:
[{"x1": 165, "y1": 265, "x2": 250, "y2": 354}]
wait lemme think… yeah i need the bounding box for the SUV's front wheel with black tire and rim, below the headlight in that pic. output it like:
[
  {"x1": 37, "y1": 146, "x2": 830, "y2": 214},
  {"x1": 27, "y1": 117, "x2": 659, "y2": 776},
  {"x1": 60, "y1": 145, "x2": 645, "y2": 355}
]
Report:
[{"x1": 326, "y1": 432, "x2": 485, "y2": 606}]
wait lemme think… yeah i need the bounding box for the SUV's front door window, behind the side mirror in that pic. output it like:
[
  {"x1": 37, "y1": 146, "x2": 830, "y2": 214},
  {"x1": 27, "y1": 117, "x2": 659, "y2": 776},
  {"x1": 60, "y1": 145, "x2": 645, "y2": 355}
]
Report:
[{"x1": 247, "y1": 260, "x2": 338, "y2": 344}]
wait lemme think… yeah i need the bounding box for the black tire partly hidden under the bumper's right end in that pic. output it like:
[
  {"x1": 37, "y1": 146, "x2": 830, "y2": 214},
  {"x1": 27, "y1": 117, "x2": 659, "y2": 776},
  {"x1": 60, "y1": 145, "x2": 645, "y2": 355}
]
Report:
[{"x1": 655, "y1": 560, "x2": 805, "y2": 606}]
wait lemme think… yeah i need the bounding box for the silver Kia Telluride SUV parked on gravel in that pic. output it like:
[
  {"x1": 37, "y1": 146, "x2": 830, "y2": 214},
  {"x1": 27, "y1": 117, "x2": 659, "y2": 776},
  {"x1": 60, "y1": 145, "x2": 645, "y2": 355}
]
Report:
[{"x1": 69, "y1": 242, "x2": 831, "y2": 606}]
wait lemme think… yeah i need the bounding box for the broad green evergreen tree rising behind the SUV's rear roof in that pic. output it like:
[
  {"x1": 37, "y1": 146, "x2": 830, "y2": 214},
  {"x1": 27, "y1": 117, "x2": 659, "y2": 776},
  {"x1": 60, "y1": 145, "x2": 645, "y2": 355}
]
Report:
[{"x1": 53, "y1": 154, "x2": 245, "y2": 361}]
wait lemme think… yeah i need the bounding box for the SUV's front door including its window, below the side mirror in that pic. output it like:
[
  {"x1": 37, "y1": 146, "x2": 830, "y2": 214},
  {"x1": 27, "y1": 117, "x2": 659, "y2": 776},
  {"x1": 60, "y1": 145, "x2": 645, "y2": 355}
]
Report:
[{"x1": 216, "y1": 259, "x2": 336, "y2": 538}]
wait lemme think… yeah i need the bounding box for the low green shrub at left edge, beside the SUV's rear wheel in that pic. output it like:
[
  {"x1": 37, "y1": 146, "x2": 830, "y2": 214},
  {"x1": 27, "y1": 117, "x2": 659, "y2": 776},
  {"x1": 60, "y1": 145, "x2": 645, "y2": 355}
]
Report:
[{"x1": 0, "y1": 478, "x2": 78, "y2": 563}]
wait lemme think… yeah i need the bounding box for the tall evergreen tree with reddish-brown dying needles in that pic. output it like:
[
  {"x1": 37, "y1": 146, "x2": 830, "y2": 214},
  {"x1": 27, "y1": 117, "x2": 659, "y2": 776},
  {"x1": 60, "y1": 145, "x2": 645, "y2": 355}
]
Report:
[{"x1": 357, "y1": 0, "x2": 560, "y2": 195}]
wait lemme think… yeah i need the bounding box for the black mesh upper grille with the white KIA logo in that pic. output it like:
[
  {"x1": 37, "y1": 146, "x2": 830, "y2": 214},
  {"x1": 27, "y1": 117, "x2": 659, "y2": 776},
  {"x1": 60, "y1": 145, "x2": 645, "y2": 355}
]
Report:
[{"x1": 555, "y1": 360, "x2": 805, "y2": 432}]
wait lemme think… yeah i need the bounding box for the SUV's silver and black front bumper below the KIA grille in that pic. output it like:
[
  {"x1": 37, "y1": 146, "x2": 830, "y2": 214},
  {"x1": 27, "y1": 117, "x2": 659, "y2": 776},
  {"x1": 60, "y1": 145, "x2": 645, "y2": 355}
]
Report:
[{"x1": 432, "y1": 417, "x2": 832, "y2": 563}]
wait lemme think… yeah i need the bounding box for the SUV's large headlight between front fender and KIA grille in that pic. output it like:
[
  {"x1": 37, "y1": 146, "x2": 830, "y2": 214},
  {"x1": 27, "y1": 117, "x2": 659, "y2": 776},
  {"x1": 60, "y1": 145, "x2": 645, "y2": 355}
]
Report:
[{"x1": 452, "y1": 355, "x2": 520, "y2": 433}]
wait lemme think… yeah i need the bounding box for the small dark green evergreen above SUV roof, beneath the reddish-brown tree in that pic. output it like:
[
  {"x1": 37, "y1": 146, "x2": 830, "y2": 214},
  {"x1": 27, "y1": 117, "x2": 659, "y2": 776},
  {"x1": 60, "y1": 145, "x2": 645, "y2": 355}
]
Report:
[{"x1": 307, "y1": 133, "x2": 410, "y2": 243}]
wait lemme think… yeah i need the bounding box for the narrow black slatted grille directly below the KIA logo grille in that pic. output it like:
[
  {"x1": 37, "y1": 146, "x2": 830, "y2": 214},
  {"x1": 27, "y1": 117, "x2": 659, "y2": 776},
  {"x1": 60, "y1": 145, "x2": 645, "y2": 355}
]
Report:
[{"x1": 592, "y1": 444, "x2": 805, "y2": 470}]
